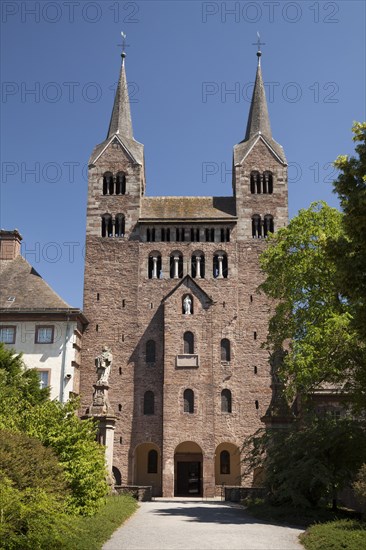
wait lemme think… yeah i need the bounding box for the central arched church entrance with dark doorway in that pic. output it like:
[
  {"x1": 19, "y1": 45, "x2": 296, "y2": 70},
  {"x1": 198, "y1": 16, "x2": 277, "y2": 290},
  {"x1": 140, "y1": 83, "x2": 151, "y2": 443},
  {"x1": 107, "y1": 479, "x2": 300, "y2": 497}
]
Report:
[{"x1": 174, "y1": 441, "x2": 203, "y2": 497}]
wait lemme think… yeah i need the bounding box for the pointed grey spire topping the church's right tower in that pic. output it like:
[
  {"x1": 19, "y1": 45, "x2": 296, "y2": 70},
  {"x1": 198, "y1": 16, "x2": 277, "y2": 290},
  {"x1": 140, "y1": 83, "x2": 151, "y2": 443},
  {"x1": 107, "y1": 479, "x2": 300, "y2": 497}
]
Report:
[{"x1": 244, "y1": 43, "x2": 272, "y2": 141}]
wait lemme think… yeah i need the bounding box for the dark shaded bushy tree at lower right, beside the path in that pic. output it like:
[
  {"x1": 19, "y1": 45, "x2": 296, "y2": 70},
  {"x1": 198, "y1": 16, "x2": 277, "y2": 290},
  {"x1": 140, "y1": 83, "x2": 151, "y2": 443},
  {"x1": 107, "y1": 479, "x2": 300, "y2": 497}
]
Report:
[{"x1": 243, "y1": 415, "x2": 366, "y2": 508}]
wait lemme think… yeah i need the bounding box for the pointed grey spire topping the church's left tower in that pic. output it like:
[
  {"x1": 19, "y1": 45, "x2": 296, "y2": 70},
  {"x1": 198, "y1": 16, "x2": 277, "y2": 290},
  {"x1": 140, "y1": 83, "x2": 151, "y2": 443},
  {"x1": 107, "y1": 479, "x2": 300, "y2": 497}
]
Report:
[{"x1": 107, "y1": 33, "x2": 133, "y2": 139}]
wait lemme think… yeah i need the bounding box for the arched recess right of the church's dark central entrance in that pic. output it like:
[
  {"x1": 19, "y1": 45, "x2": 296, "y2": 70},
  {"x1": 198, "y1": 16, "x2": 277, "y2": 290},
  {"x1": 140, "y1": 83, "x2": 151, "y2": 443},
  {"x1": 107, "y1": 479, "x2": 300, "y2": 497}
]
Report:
[{"x1": 215, "y1": 443, "x2": 241, "y2": 485}]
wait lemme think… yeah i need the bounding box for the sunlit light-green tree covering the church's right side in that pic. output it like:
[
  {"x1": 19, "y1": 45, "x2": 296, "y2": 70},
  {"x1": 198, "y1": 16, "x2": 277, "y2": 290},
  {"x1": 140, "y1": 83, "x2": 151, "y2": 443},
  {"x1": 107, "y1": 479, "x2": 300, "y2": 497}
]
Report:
[{"x1": 260, "y1": 202, "x2": 365, "y2": 404}]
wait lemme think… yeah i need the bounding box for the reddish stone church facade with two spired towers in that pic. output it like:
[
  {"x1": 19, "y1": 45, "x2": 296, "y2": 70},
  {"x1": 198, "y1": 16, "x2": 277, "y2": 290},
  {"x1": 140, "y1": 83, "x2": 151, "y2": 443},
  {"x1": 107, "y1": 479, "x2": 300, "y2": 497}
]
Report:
[{"x1": 81, "y1": 45, "x2": 288, "y2": 497}]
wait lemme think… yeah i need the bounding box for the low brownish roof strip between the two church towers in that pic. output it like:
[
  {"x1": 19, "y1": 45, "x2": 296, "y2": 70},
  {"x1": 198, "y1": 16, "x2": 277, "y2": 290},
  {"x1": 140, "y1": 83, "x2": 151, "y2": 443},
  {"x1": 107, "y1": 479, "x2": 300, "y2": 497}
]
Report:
[{"x1": 140, "y1": 197, "x2": 236, "y2": 222}]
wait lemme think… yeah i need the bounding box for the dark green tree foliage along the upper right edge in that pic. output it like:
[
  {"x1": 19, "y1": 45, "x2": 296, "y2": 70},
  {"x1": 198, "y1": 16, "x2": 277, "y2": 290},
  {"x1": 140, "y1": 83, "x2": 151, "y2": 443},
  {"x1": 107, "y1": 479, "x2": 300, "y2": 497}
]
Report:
[{"x1": 334, "y1": 122, "x2": 366, "y2": 341}]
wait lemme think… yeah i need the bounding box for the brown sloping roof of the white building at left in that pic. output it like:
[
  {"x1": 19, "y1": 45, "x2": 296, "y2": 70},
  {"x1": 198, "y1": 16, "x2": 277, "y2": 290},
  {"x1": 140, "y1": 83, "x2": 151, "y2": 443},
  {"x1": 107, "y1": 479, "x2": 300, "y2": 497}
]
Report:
[{"x1": 0, "y1": 256, "x2": 72, "y2": 311}]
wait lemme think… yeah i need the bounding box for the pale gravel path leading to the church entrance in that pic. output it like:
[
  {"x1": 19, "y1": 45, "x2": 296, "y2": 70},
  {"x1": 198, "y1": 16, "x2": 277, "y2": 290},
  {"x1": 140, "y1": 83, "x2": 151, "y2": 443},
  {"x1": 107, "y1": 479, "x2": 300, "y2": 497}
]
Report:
[{"x1": 103, "y1": 500, "x2": 303, "y2": 550}]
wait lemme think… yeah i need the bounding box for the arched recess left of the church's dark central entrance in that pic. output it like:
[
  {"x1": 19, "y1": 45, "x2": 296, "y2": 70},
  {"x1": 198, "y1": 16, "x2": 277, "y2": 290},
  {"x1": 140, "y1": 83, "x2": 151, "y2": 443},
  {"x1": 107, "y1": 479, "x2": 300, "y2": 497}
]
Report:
[{"x1": 134, "y1": 443, "x2": 161, "y2": 497}]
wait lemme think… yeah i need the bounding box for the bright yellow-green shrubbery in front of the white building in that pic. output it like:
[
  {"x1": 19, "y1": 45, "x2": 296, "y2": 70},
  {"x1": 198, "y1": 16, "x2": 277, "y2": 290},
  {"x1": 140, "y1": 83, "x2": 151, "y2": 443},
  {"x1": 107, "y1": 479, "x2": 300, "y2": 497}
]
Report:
[{"x1": 0, "y1": 346, "x2": 108, "y2": 515}]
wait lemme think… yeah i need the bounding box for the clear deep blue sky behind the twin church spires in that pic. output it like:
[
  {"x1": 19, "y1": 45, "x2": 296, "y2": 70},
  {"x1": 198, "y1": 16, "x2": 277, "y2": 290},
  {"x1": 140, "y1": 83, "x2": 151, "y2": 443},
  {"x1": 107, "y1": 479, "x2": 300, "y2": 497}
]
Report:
[{"x1": 0, "y1": 0, "x2": 366, "y2": 307}]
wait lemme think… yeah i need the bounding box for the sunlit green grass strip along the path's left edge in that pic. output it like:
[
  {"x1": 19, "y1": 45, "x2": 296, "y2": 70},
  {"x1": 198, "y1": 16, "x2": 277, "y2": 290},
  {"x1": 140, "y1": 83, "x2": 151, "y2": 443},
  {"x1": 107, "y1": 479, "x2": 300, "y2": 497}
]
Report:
[{"x1": 62, "y1": 495, "x2": 138, "y2": 550}]
